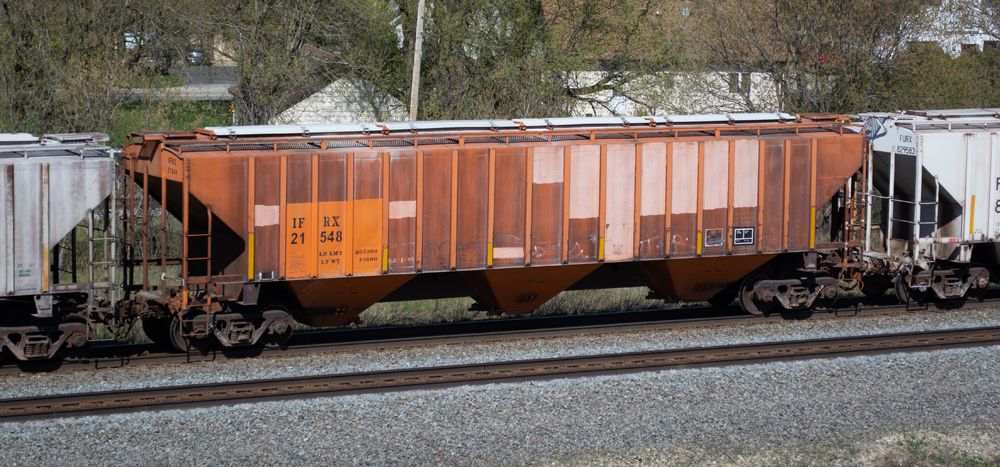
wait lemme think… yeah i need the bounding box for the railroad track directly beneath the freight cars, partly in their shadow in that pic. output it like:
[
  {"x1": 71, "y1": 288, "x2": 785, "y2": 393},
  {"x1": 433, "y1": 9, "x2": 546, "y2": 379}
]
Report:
[{"x1": 0, "y1": 289, "x2": 1000, "y2": 375}]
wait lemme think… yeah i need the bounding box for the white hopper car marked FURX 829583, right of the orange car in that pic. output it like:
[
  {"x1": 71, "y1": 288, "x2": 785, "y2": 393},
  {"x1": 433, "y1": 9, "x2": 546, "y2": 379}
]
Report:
[{"x1": 861, "y1": 109, "x2": 1000, "y2": 302}]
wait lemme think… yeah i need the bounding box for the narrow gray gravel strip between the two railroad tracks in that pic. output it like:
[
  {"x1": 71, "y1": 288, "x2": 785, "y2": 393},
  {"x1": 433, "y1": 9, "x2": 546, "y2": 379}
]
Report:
[{"x1": 0, "y1": 309, "x2": 1000, "y2": 398}]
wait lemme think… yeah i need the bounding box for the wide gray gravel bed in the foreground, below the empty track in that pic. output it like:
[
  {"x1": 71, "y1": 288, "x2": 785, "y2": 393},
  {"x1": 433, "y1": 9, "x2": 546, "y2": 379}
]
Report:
[{"x1": 0, "y1": 347, "x2": 1000, "y2": 465}]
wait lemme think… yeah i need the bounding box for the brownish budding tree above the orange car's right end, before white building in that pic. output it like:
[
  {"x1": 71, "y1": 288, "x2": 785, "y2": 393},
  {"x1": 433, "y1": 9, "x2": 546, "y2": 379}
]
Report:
[{"x1": 681, "y1": 0, "x2": 927, "y2": 112}]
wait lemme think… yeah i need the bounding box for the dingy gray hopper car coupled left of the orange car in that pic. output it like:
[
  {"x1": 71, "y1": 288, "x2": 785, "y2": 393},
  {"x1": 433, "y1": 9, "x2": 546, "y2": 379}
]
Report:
[{"x1": 0, "y1": 133, "x2": 115, "y2": 360}]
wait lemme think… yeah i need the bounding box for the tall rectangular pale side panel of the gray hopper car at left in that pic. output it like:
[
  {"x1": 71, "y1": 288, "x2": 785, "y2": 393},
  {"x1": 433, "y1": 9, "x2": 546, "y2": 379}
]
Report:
[{"x1": 13, "y1": 164, "x2": 46, "y2": 294}]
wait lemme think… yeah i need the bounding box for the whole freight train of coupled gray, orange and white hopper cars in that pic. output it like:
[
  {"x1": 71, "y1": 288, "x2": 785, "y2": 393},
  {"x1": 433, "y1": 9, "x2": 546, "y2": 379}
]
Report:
[{"x1": 0, "y1": 109, "x2": 1000, "y2": 360}]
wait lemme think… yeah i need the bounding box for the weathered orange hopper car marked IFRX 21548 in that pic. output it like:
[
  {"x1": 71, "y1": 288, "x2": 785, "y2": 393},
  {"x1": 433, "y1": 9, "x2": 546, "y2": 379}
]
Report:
[{"x1": 124, "y1": 114, "x2": 866, "y2": 349}]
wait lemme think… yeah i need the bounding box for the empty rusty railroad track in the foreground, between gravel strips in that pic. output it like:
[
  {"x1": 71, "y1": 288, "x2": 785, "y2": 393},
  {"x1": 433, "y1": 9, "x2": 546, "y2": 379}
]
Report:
[{"x1": 0, "y1": 327, "x2": 1000, "y2": 422}]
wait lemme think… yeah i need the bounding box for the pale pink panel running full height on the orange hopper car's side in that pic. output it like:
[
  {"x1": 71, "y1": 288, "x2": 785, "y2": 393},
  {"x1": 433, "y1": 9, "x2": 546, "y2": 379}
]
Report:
[{"x1": 604, "y1": 144, "x2": 635, "y2": 261}]
